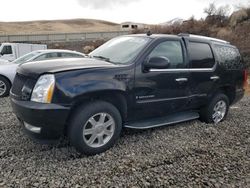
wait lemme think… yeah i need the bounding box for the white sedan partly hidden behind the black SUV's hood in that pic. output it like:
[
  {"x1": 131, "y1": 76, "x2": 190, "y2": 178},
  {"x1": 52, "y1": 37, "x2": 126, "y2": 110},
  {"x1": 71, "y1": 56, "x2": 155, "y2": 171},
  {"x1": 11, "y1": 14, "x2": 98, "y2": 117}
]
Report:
[{"x1": 0, "y1": 50, "x2": 85, "y2": 97}]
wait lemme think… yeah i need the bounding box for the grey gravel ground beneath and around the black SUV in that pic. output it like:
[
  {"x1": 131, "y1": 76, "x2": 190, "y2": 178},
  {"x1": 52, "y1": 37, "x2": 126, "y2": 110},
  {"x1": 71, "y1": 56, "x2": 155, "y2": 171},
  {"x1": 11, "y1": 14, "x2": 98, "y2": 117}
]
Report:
[{"x1": 0, "y1": 97, "x2": 250, "y2": 187}]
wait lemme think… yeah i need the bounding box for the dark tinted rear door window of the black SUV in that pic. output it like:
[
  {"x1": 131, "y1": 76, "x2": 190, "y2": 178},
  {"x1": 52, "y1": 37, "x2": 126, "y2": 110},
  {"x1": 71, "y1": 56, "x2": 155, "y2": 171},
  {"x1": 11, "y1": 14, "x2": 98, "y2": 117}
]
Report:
[{"x1": 189, "y1": 42, "x2": 215, "y2": 68}]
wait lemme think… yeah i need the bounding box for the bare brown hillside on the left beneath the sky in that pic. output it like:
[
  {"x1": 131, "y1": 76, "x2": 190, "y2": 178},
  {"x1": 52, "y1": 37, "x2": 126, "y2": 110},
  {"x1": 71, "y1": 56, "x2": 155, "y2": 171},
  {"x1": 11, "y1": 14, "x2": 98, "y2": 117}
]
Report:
[{"x1": 0, "y1": 19, "x2": 120, "y2": 35}]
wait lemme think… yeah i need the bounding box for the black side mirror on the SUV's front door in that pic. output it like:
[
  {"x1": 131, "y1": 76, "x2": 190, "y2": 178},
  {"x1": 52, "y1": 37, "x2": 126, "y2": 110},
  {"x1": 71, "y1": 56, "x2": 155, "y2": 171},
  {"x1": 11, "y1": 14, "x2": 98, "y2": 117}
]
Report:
[{"x1": 144, "y1": 56, "x2": 170, "y2": 70}]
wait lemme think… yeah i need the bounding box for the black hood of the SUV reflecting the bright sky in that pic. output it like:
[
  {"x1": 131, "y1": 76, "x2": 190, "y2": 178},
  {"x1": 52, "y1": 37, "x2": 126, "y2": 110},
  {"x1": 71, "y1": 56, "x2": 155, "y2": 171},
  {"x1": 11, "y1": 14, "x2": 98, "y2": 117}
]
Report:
[{"x1": 17, "y1": 58, "x2": 118, "y2": 77}]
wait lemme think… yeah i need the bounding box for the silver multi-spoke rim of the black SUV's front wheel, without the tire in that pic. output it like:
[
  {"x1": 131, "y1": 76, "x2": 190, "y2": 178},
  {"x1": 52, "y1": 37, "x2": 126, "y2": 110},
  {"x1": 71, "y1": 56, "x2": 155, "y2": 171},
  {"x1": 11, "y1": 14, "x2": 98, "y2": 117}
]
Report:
[{"x1": 83, "y1": 112, "x2": 115, "y2": 148}]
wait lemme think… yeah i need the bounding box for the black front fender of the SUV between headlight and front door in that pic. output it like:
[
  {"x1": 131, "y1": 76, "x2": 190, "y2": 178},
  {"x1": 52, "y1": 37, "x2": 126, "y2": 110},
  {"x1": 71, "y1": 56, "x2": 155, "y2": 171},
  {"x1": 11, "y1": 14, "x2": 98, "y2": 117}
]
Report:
[{"x1": 54, "y1": 67, "x2": 134, "y2": 105}]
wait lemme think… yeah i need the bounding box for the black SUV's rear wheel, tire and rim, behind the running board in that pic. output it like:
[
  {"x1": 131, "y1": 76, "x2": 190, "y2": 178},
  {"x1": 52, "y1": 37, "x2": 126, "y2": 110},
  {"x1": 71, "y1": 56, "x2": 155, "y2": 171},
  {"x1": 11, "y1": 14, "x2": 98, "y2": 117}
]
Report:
[{"x1": 200, "y1": 93, "x2": 229, "y2": 123}]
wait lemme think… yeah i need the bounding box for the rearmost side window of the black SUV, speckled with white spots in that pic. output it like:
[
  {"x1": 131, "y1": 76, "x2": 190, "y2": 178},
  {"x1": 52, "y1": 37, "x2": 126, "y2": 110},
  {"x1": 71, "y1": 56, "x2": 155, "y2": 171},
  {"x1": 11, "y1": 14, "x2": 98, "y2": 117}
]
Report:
[{"x1": 215, "y1": 45, "x2": 243, "y2": 69}]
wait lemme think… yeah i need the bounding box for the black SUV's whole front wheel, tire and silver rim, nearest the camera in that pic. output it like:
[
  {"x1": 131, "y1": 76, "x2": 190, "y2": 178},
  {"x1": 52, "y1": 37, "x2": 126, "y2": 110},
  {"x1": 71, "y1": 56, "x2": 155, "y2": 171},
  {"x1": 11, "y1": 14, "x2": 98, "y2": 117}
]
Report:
[{"x1": 68, "y1": 101, "x2": 122, "y2": 155}]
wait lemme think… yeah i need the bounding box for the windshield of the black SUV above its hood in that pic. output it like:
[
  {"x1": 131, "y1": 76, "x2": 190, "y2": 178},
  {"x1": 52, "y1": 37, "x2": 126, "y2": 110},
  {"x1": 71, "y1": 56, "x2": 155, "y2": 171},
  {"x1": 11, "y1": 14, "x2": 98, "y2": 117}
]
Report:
[{"x1": 89, "y1": 36, "x2": 151, "y2": 64}]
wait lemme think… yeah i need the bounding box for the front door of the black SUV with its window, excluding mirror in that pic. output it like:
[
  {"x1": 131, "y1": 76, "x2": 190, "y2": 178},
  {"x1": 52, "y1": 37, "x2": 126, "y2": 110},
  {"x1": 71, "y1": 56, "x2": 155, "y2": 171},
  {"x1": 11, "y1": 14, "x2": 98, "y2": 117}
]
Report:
[{"x1": 132, "y1": 39, "x2": 190, "y2": 120}]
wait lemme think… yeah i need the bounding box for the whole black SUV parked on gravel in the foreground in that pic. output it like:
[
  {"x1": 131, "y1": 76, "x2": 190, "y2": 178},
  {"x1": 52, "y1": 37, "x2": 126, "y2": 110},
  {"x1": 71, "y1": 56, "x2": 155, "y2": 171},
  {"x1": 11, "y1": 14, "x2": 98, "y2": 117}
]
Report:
[{"x1": 11, "y1": 34, "x2": 247, "y2": 155}]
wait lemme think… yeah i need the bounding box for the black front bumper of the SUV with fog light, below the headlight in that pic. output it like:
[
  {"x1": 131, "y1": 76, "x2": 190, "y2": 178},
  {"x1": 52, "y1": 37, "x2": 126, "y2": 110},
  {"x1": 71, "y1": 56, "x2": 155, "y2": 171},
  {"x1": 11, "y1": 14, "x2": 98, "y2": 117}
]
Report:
[{"x1": 11, "y1": 98, "x2": 70, "y2": 143}]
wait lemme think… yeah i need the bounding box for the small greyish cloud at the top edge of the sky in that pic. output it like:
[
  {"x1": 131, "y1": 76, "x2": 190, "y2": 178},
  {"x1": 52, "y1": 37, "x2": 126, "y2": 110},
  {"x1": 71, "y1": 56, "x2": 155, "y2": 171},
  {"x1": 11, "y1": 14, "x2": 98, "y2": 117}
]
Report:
[{"x1": 77, "y1": 0, "x2": 140, "y2": 9}]
